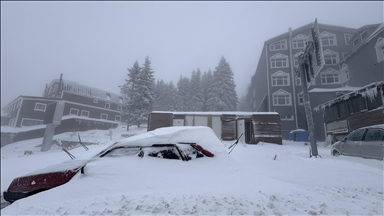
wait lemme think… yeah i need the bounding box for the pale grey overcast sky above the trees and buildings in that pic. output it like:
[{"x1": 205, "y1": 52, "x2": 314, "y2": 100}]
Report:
[{"x1": 1, "y1": 1, "x2": 384, "y2": 107}]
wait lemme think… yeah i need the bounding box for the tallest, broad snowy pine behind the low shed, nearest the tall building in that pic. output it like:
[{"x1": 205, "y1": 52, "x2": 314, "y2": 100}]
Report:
[{"x1": 207, "y1": 57, "x2": 238, "y2": 111}]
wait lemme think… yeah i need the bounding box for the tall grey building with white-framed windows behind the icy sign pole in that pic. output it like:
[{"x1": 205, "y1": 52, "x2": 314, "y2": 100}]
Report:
[{"x1": 247, "y1": 23, "x2": 356, "y2": 140}]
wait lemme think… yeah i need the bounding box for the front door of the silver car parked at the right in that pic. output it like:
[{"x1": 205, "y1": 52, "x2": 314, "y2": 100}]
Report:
[{"x1": 341, "y1": 128, "x2": 366, "y2": 156}]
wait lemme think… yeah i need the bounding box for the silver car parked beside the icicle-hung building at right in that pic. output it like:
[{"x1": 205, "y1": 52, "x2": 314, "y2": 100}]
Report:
[{"x1": 331, "y1": 124, "x2": 384, "y2": 160}]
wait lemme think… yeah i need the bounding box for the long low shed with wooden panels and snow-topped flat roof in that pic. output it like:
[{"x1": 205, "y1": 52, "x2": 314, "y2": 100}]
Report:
[{"x1": 148, "y1": 111, "x2": 282, "y2": 145}]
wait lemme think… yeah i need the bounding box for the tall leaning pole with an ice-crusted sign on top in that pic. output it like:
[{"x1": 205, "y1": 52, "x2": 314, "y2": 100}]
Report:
[{"x1": 296, "y1": 19, "x2": 325, "y2": 157}]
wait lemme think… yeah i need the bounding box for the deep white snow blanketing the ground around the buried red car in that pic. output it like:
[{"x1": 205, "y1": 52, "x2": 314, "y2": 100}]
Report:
[{"x1": 1, "y1": 124, "x2": 384, "y2": 215}]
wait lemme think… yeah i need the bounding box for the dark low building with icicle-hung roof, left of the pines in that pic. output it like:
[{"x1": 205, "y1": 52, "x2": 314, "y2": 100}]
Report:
[{"x1": 1, "y1": 74, "x2": 125, "y2": 145}]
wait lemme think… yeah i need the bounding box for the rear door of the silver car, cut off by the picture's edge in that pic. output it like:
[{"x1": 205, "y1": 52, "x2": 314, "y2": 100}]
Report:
[{"x1": 360, "y1": 128, "x2": 384, "y2": 160}]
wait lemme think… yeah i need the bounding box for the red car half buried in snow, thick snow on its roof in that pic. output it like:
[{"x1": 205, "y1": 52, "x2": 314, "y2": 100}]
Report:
[{"x1": 3, "y1": 127, "x2": 229, "y2": 203}]
